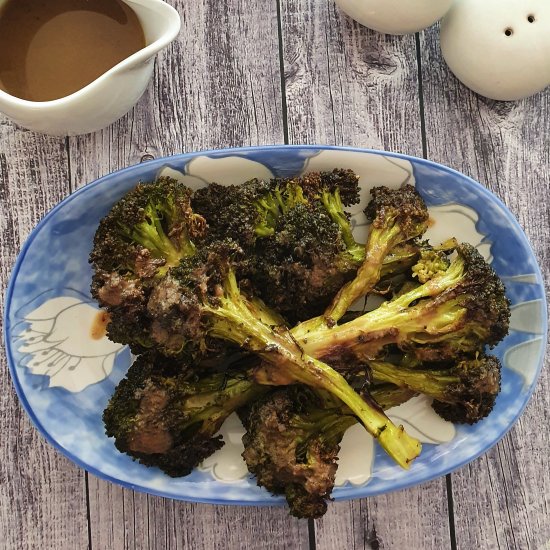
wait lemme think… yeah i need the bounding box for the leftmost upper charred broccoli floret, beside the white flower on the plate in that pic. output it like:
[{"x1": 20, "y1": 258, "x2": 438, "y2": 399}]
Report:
[{"x1": 90, "y1": 178, "x2": 206, "y2": 352}]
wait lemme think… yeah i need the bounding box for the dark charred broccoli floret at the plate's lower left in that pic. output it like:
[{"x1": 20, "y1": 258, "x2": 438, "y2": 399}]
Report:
[{"x1": 103, "y1": 352, "x2": 266, "y2": 477}]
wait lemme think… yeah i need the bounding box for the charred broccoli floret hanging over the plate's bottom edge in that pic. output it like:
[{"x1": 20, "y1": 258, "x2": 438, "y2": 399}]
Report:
[{"x1": 240, "y1": 385, "x2": 411, "y2": 518}]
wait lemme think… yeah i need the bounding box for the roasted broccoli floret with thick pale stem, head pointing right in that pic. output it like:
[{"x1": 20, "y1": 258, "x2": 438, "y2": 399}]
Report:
[{"x1": 293, "y1": 244, "x2": 510, "y2": 363}]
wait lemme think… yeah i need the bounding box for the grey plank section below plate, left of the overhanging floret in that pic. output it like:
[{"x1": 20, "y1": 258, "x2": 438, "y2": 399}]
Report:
[{"x1": 89, "y1": 476, "x2": 308, "y2": 550}]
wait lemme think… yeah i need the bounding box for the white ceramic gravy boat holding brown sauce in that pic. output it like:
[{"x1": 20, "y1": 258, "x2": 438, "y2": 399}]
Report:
[{"x1": 0, "y1": 0, "x2": 181, "y2": 136}]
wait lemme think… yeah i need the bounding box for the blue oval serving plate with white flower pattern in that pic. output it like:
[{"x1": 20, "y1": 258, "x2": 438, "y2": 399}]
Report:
[{"x1": 4, "y1": 146, "x2": 547, "y2": 505}]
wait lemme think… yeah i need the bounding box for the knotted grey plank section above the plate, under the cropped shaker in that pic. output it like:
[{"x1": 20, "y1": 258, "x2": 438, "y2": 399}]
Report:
[{"x1": 281, "y1": 0, "x2": 422, "y2": 156}]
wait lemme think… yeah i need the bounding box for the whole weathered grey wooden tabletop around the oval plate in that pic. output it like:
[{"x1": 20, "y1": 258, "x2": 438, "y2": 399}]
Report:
[{"x1": 0, "y1": 0, "x2": 550, "y2": 550}]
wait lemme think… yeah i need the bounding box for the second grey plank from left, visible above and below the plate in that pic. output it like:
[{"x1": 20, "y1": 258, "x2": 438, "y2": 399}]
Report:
[{"x1": 70, "y1": 0, "x2": 308, "y2": 550}]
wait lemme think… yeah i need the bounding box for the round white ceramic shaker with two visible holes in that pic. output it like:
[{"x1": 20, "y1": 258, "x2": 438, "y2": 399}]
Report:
[{"x1": 441, "y1": 0, "x2": 550, "y2": 100}]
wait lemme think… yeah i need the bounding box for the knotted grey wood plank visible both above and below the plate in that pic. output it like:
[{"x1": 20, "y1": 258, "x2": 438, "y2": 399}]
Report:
[{"x1": 282, "y1": 0, "x2": 450, "y2": 550}]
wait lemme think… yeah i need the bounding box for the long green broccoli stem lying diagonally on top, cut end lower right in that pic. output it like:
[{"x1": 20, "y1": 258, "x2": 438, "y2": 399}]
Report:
[{"x1": 205, "y1": 271, "x2": 421, "y2": 468}]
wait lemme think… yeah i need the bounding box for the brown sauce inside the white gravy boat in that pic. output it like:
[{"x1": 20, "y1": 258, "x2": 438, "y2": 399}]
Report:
[{"x1": 0, "y1": 0, "x2": 145, "y2": 101}]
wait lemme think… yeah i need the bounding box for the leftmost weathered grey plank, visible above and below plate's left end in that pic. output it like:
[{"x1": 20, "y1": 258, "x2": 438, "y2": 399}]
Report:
[{"x1": 0, "y1": 123, "x2": 88, "y2": 550}]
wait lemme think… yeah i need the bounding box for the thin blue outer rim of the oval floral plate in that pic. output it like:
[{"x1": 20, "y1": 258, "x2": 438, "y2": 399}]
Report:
[{"x1": 3, "y1": 145, "x2": 548, "y2": 506}]
